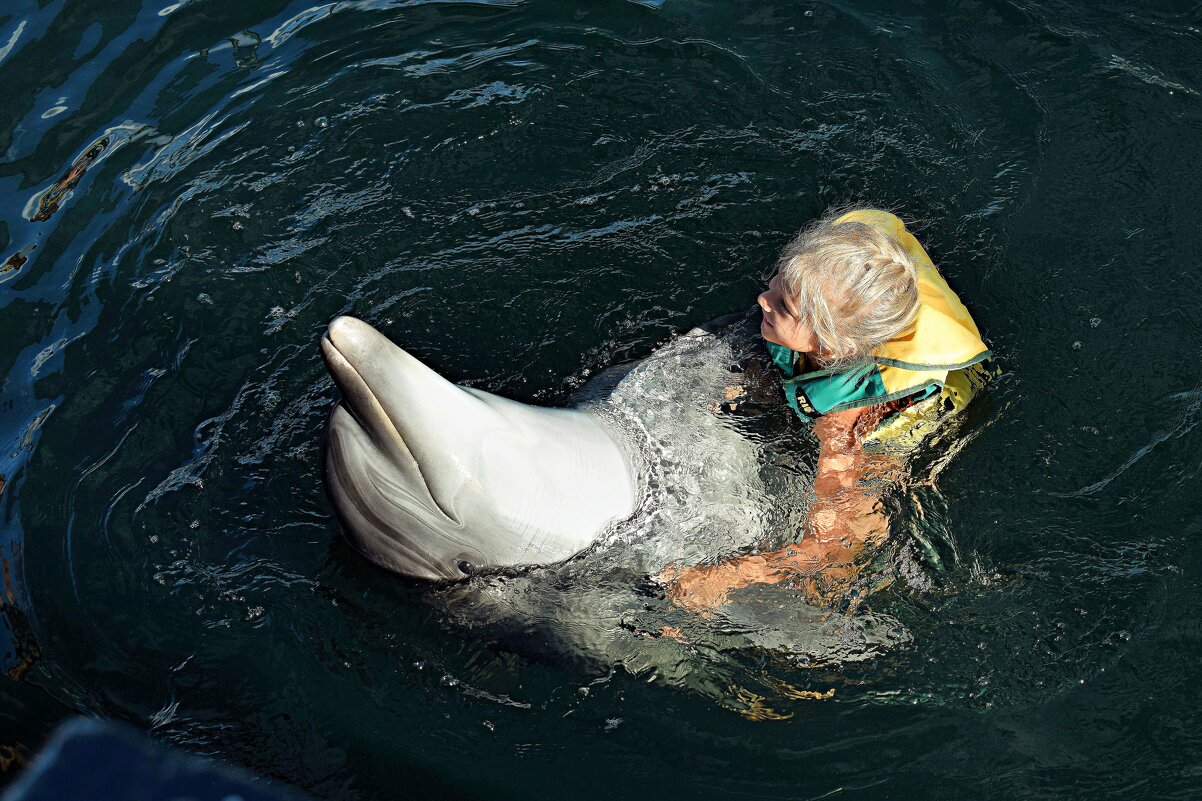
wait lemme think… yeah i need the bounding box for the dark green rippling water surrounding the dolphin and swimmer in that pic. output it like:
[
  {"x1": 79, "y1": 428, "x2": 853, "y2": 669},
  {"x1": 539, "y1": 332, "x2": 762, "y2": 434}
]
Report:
[{"x1": 0, "y1": 0, "x2": 1202, "y2": 799}]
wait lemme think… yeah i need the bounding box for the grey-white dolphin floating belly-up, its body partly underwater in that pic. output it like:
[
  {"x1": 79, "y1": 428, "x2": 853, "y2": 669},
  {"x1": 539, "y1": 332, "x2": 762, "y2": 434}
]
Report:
[{"x1": 321, "y1": 312, "x2": 921, "y2": 708}]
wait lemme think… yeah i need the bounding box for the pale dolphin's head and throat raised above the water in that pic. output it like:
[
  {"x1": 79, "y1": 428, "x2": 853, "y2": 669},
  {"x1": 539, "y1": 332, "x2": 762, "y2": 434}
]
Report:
[{"x1": 321, "y1": 316, "x2": 635, "y2": 581}]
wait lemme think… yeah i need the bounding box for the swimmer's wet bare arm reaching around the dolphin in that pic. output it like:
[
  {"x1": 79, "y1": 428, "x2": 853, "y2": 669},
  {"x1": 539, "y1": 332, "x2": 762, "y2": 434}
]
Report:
[{"x1": 660, "y1": 407, "x2": 897, "y2": 617}]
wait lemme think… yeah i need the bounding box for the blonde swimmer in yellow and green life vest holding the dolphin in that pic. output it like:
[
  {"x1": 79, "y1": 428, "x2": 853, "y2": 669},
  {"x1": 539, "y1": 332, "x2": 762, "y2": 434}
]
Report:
[{"x1": 660, "y1": 209, "x2": 990, "y2": 615}]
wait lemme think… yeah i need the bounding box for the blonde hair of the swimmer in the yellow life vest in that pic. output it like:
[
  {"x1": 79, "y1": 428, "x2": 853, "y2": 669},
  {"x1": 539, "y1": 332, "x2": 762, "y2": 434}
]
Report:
[{"x1": 776, "y1": 209, "x2": 918, "y2": 363}]
